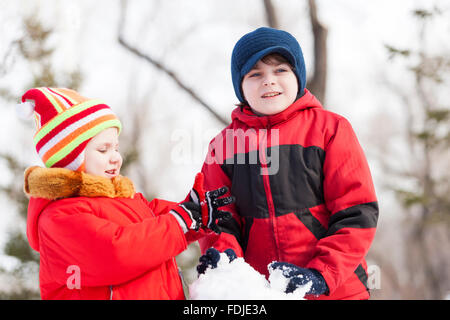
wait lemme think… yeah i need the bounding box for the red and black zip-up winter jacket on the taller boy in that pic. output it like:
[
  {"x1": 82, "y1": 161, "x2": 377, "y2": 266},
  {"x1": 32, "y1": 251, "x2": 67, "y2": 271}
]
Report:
[{"x1": 199, "y1": 90, "x2": 378, "y2": 299}]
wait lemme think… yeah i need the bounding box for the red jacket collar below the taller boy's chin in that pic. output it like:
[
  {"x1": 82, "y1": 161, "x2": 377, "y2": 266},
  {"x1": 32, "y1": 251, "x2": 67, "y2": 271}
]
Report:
[{"x1": 231, "y1": 89, "x2": 322, "y2": 128}]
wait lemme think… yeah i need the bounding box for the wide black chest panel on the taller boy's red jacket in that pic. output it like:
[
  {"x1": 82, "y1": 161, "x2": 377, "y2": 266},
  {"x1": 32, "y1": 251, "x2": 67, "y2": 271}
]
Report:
[{"x1": 221, "y1": 145, "x2": 325, "y2": 218}]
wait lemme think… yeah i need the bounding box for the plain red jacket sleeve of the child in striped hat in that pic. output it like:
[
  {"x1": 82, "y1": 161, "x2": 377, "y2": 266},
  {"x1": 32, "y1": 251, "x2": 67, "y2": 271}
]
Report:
[{"x1": 39, "y1": 200, "x2": 186, "y2": 286}]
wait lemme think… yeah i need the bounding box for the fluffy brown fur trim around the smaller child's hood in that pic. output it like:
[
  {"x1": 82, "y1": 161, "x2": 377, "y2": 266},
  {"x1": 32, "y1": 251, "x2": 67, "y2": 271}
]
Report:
[{"x1": 24, "y1": 166, "x2": 135, "y2": 200}]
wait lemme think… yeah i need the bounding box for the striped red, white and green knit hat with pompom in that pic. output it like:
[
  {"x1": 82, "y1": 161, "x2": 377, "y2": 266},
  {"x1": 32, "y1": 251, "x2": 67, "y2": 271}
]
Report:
[{"x1": 17, "y1": 88, "x2": 122, "y2": 171}]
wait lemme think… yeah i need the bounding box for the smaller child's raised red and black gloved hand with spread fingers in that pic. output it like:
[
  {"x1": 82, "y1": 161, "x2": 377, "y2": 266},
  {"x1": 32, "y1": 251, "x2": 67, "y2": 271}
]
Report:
[{"x1": 189, "y1": 172, "x2": 235, "y2": 233}]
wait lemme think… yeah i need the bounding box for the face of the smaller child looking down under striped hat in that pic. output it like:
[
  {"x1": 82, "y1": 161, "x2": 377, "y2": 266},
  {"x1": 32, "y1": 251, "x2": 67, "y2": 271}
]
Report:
[{"x1": 85, "y1": 128, "x2": 122, "y2": 178}]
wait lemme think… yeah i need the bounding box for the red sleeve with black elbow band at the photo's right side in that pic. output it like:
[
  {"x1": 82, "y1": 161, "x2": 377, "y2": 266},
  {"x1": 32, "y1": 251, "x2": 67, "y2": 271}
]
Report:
[{"x1": 307, "y1": 118, "x2": 378, "y2": 293}]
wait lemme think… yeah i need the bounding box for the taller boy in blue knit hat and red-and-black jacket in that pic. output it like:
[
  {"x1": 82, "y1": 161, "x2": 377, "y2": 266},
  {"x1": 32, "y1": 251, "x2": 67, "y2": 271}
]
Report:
[{"x1": 198, "y1": 28, "x2": 378, "y2": 299}]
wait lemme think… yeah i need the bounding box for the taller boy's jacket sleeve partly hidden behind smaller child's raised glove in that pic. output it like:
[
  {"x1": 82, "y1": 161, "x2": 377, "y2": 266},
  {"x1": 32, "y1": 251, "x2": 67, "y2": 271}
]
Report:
[{"x1": 198, "y1": 135, "x2": 243, "y2": 257}]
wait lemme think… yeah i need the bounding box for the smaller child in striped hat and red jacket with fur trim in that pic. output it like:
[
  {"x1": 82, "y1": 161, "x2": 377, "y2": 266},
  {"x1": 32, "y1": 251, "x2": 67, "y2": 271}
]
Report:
[{"x1": 18, "y1": 88, "x2": 232, "y2": 300}]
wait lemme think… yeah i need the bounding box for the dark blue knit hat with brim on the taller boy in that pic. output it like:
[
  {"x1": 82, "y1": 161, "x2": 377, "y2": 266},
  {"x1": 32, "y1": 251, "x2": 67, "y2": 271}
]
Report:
[{"x1": 231, "y1": 27, "x2": 306, "y2": 102}]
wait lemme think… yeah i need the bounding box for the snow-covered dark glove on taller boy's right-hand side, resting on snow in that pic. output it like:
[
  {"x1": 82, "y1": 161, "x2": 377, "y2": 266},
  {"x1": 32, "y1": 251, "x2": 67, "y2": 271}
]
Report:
[{"x1": 268, "y1": 262, "x2": 329, "y2": 296}]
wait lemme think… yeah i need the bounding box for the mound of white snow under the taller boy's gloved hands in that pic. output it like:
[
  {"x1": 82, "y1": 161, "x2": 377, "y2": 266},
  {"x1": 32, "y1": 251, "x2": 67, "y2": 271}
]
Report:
[{"x1": 189, "y1": 253, "x2": 311, "y2": 300}]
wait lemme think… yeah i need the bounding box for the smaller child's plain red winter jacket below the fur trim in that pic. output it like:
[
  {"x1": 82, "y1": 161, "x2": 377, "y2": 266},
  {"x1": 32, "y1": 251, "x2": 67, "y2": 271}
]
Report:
[{"x1": 26, "y1": 168, "x2": 187, "y2": 300}]
